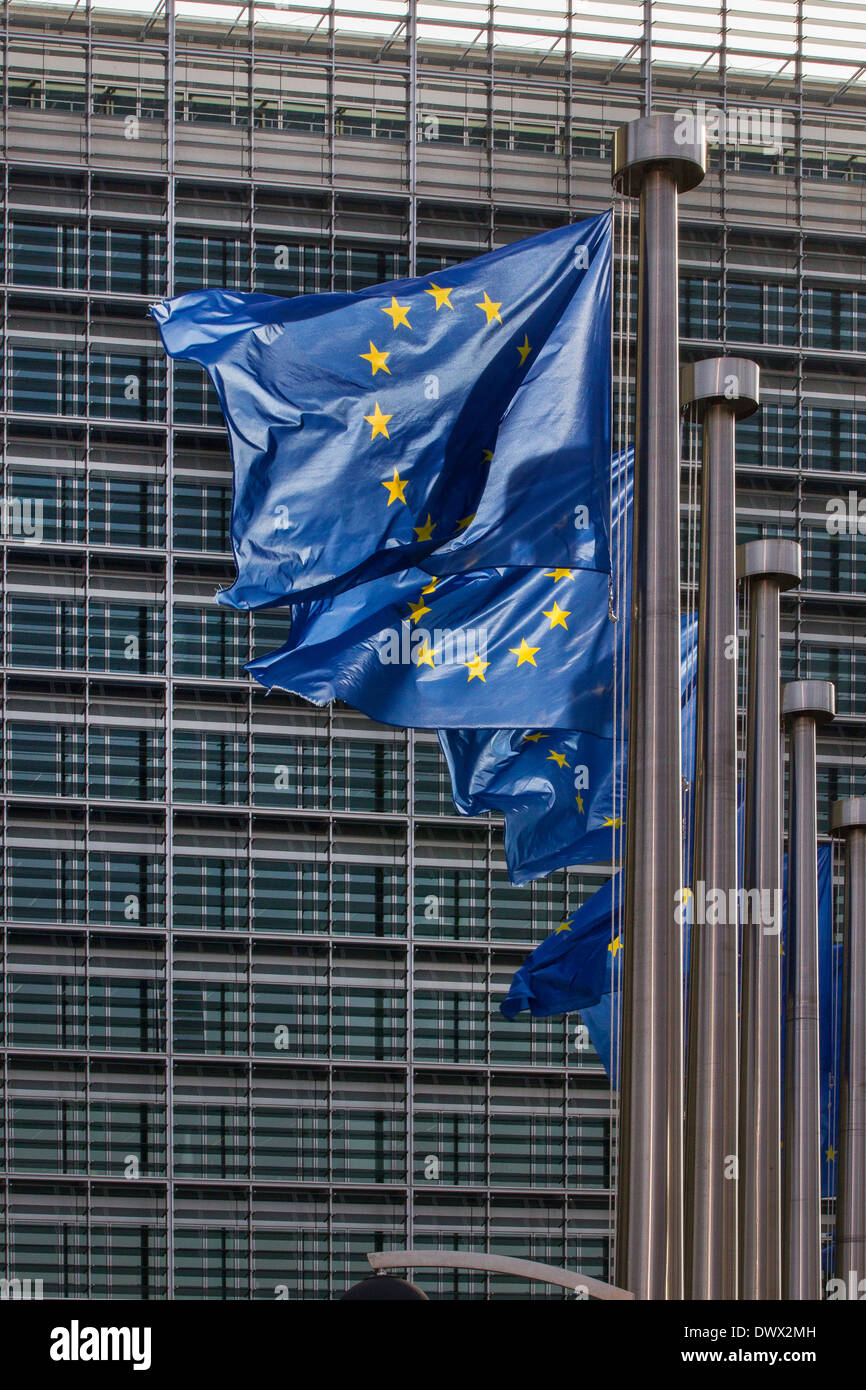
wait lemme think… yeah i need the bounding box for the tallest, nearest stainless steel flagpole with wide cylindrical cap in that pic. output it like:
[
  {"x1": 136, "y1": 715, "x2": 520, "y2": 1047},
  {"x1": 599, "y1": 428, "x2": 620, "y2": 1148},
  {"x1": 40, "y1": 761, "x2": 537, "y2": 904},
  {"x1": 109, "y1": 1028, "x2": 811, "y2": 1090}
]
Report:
[{"x1": 613, "y1": 114, "x2": 706, "y2": 1298}]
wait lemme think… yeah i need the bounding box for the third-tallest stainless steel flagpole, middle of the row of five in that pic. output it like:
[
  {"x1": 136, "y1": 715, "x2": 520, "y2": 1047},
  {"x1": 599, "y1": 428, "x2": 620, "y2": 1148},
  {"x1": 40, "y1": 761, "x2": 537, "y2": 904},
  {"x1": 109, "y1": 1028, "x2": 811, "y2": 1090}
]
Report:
[{"x1": 737, "y1": 538, "x2": 802, "y2": 1300}]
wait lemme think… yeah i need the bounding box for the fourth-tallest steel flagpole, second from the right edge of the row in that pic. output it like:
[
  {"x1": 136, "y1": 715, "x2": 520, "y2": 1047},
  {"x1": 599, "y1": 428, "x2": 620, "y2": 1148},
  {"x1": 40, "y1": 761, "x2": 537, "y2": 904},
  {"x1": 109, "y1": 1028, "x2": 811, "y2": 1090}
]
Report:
[{"x1": 781, "y1": 681, "x2": 835, "y2": 1300}]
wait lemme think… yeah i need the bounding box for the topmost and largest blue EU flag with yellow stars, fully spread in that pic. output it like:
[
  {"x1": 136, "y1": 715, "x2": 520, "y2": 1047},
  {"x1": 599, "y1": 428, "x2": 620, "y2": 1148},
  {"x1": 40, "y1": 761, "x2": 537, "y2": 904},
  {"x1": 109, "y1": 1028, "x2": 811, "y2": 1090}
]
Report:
[{"x1": 152, "y1": 213, "x2": 610, "y2": 609}]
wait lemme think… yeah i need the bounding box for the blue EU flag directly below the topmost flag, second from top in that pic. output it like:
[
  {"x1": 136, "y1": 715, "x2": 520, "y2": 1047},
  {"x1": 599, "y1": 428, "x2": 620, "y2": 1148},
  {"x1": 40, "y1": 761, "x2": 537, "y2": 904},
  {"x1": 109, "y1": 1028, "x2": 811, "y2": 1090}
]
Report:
[{"x1": 246, "y1": 558, "x2": 616, "y2": 739}]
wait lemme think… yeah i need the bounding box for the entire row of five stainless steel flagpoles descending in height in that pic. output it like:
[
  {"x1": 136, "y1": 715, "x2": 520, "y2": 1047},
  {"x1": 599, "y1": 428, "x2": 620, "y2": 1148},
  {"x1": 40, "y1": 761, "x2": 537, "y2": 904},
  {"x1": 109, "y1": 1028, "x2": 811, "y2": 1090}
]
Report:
[{"x1": 613, "y1": 113, "x2": 866, "y2": 1300}]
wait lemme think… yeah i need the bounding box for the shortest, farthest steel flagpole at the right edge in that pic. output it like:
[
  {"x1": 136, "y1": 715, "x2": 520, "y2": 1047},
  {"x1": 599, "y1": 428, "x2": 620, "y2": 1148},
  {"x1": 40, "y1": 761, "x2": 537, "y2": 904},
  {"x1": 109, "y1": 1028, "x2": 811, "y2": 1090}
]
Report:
[{"x1": 833, "y1": 796, "x2": 866, "y2": 1298}]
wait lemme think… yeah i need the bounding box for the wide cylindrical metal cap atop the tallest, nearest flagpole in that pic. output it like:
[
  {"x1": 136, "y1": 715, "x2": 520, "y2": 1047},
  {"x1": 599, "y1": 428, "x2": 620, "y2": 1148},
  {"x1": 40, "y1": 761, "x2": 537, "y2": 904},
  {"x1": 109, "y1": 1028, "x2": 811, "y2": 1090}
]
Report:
[{"x1": 610, "y1": 111, "x2": 706, "y2": 197}]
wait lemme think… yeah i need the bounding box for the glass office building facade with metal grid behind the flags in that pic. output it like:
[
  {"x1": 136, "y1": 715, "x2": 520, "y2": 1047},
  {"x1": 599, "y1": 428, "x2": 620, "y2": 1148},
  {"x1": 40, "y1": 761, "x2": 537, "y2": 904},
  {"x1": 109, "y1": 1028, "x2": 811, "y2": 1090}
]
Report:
[{"x1": 0, "y1": 0, "x2": 866, "y2": 1298}]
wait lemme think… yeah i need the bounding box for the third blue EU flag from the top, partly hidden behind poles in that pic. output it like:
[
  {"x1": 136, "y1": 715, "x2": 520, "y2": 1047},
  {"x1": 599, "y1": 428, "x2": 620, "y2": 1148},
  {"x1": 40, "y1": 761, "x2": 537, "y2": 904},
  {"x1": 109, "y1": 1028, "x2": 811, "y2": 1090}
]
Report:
[{"x1": 439, "y1": 614, "x2": 698, "y2": 884}]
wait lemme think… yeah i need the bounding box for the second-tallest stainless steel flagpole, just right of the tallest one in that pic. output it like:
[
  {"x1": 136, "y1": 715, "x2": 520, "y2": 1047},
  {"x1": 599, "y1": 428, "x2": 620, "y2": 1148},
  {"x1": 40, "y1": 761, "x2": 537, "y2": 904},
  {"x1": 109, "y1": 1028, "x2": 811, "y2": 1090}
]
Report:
[{"x1": 683, "y1": 357, "x2": 759, "y2": 1298}]
